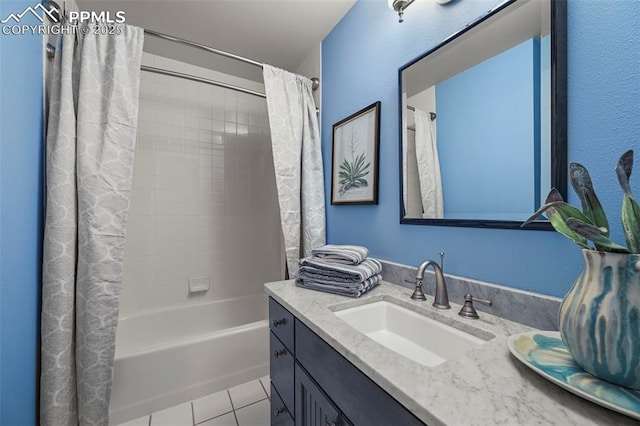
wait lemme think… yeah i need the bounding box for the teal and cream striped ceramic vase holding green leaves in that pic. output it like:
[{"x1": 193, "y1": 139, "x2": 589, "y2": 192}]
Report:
[{"x1": 559, "y1": 250, "x2": 640, "y2": 389}]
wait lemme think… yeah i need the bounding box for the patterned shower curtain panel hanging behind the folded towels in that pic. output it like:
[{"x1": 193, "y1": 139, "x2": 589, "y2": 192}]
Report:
[{"x1": 263, "y1": 65, "x2": 326, "y2": 278}]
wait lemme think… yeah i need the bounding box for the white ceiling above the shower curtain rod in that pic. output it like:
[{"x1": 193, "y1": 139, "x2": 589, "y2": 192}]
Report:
[{"x1": 77, "y1": 0, "x2": 355, "y2": 81}]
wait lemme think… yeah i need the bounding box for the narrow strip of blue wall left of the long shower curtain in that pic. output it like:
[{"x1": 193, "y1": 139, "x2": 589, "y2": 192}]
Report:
[{"x1": 0, "y1": 0, "x2": 43, "y2": 426}]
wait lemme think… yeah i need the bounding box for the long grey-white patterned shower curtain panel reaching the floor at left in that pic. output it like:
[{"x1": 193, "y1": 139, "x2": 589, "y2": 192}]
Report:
[{"x1": 40, "y1": 25, "x2": 143, "y2": 426}]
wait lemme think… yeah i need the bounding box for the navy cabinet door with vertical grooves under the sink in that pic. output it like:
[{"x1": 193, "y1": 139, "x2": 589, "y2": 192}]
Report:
[{"x1": 295, "y1": 363, "x2": 340, "y2": 426}]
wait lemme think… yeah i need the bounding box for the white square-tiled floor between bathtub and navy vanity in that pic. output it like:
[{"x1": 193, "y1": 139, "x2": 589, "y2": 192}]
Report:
[{"x1": 120, "y1": 376, "x2": 270, "y2": 426}]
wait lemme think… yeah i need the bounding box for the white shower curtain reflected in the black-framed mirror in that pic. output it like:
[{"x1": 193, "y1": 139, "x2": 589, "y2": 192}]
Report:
[{"x1": 415, "y1": 108, "x2": 444, "y2": 219}]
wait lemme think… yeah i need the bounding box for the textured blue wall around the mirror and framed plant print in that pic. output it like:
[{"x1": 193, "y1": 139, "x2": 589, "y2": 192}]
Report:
[{"x1": 322, "y1": 0, "x2": 640, "y2": 296}]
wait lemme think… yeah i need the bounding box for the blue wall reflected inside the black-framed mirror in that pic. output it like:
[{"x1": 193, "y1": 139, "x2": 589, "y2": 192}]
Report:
[{"x1": 436, "y1": 39, "x2": 540, "y2": 220}]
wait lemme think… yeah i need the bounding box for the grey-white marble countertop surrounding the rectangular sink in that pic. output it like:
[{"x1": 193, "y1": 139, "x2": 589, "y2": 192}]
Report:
[{"x1": 265, "y1": 281, "x2": 638, "y2": 426}]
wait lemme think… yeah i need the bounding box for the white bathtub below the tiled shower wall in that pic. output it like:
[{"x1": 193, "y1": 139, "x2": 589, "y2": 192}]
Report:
[{"x1": 109, "y1": 295, "x2": 269, "y2": 425}]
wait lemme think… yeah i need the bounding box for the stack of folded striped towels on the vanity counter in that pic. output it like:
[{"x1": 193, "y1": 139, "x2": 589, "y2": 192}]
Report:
[{"x1": 296, "y1": 244, "x2": 382, "y2": 297}]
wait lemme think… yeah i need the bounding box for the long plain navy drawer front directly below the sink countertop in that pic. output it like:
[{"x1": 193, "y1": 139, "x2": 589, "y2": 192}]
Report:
[{"x1": 296, "y1": 320, "x2": 424, "y2": 426}]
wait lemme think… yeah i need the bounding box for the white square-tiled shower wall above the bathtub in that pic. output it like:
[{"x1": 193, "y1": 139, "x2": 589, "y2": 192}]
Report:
[{"x1": 120, "y1": 53, "x2": 281, "y2": 316}]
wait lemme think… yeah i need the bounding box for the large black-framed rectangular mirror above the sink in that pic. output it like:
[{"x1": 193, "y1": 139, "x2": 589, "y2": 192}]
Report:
[{"x1": 399, "y1": 0, "x2": 567, "y2": 230}]
